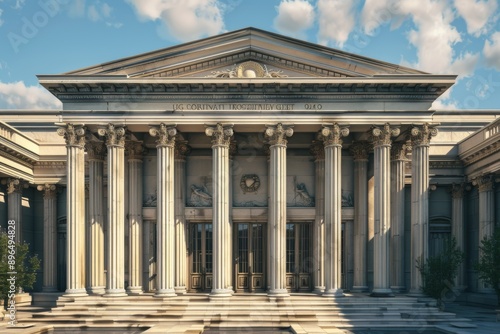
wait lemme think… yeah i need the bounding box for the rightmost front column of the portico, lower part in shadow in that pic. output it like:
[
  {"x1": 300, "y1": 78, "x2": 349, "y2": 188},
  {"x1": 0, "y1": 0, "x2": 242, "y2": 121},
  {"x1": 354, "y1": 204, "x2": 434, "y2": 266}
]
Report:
[{"x1": 410, "y1": 123, "x2": 437, "y2": 296}]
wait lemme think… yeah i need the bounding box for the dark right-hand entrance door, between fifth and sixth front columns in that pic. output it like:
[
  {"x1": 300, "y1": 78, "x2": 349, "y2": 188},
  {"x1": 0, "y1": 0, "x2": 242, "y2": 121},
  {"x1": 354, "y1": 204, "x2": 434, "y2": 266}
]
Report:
[{"x1": 286, "y1": 223, "x2": 313, "y2": 291}]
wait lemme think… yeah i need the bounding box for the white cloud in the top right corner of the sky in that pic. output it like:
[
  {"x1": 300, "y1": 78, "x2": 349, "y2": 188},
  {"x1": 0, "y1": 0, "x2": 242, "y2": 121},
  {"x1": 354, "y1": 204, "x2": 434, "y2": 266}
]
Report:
[{"x1": 455, "y1": 0, "x2": 498, "y2": 37}]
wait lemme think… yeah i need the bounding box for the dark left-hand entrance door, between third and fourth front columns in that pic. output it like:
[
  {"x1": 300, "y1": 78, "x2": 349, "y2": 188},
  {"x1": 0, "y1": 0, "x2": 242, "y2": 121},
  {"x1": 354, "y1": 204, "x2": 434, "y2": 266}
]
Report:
[{"x1": 189, "y1": 223, "x2": 212, "y2": 292}]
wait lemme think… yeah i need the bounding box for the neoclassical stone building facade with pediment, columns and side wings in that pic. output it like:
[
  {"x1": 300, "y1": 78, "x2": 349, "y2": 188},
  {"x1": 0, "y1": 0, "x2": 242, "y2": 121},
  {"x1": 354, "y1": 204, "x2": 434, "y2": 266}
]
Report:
[{"x1": 0, "y1": 28, "x2": 500, "y2": 298}]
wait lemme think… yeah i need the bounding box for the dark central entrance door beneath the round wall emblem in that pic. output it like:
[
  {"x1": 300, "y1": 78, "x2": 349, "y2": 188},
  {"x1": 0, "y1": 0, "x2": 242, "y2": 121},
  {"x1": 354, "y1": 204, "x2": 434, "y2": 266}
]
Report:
[{"x1": 234, "y1": 223, "x2": 266, "y2": 292}]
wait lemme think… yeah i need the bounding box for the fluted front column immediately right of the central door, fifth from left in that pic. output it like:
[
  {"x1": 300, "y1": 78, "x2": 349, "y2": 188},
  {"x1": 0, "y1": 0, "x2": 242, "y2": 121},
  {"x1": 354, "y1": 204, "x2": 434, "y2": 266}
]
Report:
[{"x1": 266, "y1": 123, "x2": 293, "y2": 297}]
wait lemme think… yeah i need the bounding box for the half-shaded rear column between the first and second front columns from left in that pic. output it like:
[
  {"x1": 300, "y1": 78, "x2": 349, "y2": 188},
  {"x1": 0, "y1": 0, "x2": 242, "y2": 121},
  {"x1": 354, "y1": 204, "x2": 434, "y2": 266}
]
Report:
[{"x1": 85, "y1": 141, "x2": 106, "y2": 295}]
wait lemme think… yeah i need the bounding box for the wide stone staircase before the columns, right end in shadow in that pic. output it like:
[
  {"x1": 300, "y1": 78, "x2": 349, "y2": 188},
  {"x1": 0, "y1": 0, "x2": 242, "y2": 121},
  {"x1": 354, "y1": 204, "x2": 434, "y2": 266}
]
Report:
[{"x1": 11, "y1": 294, "x2": 474, "y2": 334}]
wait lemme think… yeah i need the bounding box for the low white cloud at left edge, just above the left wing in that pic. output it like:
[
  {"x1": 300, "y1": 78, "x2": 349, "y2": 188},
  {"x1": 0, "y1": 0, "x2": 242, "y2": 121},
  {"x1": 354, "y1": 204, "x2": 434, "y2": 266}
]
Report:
[{"x1": 0, "y1": 81, "x2": 62, "y2": 109}]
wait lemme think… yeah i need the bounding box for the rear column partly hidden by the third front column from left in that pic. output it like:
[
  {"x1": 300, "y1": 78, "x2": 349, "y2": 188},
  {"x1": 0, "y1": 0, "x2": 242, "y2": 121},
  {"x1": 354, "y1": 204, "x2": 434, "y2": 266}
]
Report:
[{"x1": 174, "y1": 139, "x2": 191, "y2": 294}]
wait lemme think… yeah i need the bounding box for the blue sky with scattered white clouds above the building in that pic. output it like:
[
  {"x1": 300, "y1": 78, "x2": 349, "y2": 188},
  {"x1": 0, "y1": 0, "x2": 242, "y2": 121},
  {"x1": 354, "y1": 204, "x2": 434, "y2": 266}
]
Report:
[{"x1": 0, "y1": 0, "x2": 500, "y2": 109}]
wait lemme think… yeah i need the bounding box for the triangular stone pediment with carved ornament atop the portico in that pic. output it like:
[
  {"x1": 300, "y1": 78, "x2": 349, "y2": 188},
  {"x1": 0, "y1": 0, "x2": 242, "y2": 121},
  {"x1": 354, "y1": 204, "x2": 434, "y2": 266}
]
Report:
[{"x1": 65, "y1": 28, "x2": 424, "y2": 78}]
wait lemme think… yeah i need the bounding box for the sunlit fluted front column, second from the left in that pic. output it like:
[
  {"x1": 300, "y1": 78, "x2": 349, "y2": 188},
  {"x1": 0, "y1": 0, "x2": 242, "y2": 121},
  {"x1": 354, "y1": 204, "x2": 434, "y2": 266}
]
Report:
[{"x1": 98, "y1": 124, "x2": 127, "y2": 297}]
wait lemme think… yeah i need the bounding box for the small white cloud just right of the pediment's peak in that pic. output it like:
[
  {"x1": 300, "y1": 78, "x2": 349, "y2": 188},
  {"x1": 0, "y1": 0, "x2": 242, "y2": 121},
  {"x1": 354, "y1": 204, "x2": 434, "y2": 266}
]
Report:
[{"x1": 274, "y1": 0, "x2": 314, "y2": 37}]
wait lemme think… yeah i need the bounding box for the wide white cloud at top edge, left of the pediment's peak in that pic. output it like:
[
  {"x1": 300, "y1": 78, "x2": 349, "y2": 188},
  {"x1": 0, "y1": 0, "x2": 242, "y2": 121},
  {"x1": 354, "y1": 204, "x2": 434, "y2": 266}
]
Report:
[{"x1": 127, "y1": 0, "x2": 224, "y2": 41}]
